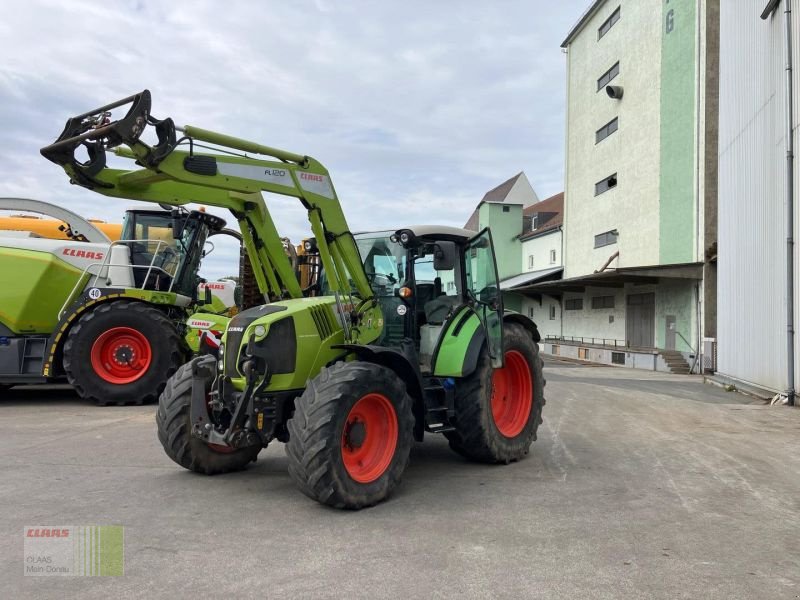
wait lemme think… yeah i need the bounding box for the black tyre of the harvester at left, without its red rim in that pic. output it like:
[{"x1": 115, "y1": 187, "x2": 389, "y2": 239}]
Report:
[{"x1": 63, "y1": 300, "x2": 188, "y2": 406}]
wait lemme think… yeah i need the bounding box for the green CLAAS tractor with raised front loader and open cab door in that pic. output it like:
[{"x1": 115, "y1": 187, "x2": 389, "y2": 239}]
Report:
[{"x1": 42, "y1": 90, "x2": 544, "y2": 509}]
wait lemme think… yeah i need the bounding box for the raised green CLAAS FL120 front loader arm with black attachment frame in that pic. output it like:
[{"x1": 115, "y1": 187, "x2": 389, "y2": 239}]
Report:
[{"x1": 41, "y1": 90, "x2": 374, "y2": 318}]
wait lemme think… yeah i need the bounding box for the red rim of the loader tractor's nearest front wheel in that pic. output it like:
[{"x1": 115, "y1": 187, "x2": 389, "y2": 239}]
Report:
[{"x1": 342, "y1": 394, "x2": 398, "y2": 483}]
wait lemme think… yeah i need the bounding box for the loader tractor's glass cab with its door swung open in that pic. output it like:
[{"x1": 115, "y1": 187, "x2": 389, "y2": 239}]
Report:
[{"x1": 355, "y1": 225, "x2": 502, "y2": 372}]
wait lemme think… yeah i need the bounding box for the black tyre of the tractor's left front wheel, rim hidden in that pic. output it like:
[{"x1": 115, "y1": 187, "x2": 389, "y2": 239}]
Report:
[{"x1": 156, "y1": 356, "x2": 261, "y2": 475}]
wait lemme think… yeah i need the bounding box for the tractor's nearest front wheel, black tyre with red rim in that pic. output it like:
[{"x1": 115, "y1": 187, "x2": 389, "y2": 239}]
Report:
[{"x1": 286, "y1": 362, "x2": 414, "y2": 509}]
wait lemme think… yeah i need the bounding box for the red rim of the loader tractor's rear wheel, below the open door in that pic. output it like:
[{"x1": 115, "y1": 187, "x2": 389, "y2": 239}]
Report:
[{"x1": 492, "y1": 350, "x2": 533, "y2": 438}]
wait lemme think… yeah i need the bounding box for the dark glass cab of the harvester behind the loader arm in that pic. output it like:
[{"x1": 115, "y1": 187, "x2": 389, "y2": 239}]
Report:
[{"x1": 115, "y1": 209, "x2": 225, "y2": 297}]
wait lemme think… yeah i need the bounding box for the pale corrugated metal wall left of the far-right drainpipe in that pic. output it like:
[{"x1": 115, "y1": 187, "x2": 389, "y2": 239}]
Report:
[{"x1": 717, "y1": 0, "x2": 788, "y2": 390}]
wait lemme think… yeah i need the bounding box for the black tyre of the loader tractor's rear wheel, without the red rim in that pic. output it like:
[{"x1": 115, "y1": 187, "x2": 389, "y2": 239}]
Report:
[{"x1": 445, "y1": 323, "x2": 545, "y2": 464}]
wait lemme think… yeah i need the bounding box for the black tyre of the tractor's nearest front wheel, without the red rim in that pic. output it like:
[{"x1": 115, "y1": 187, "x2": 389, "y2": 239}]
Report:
[{"x1": 286, "y1": 362, "x2": 414, "y2": 509}]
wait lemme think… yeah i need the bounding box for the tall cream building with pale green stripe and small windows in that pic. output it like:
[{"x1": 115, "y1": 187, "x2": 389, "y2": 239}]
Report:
[{"x1": 533, "y1": 0, "x2": 719, "y2": 370}]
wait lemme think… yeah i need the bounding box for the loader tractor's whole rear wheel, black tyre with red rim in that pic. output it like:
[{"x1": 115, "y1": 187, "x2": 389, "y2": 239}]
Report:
[{"x1": 445, "y1": 323, "x2": 545, "y2": 464}]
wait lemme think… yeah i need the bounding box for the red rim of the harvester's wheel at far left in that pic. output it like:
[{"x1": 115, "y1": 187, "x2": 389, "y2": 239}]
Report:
[{"x1": 91, "y1": 327, "x2": 153, "y2": 385}]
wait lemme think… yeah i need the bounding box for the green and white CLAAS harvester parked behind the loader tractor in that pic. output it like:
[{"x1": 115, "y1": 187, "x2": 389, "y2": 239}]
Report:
[{"x1": 0, "y1": 198, "x2": 244, "y2": 405}]
